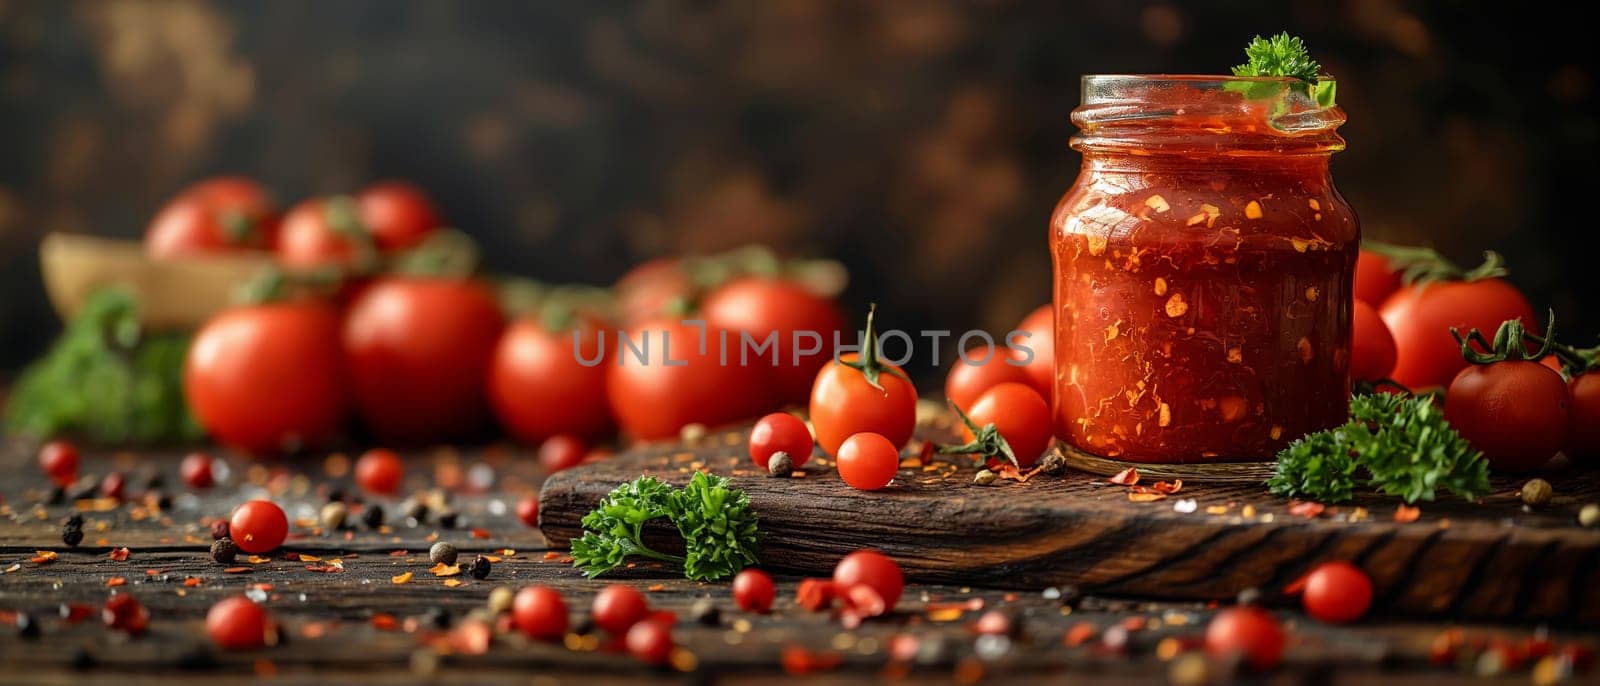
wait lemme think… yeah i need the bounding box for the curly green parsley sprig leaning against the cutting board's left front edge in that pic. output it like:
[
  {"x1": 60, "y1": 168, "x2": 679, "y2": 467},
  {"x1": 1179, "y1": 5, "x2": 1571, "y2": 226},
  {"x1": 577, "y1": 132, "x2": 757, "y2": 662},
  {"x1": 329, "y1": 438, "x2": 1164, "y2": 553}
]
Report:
[{"x1": 571, "y1": 472, "x2": 760, "y2": 580}]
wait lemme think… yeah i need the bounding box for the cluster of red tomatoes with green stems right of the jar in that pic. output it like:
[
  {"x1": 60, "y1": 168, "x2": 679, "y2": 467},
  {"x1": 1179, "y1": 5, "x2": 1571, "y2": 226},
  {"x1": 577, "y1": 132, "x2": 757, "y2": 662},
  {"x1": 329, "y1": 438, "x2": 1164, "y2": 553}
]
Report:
[{"x1": 1350, "y1": 245, "x2": 1600, "y2": 472}]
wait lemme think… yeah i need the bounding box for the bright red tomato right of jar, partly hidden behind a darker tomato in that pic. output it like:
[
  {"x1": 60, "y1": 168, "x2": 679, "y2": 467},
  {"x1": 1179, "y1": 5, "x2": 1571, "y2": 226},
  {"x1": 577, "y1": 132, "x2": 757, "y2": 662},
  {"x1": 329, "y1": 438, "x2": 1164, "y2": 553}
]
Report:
[{"x1": 1378, "y1": 278, "x2": 1536, "y2": 390}]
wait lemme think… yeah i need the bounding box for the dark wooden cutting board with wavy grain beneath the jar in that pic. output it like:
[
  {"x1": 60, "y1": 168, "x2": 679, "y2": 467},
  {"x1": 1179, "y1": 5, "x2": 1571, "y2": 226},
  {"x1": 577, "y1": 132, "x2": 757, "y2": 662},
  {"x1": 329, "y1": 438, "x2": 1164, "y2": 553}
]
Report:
[{"x1": 541, "y1": 415, "x2": 1600, "y2": 625}]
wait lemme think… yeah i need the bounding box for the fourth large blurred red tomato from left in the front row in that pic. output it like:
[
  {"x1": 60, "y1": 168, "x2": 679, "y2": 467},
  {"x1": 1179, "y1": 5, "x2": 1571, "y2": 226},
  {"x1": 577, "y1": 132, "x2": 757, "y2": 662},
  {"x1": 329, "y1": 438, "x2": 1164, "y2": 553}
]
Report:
[{"x1": 605, "y1": 317, "x2": 771, "y2": 440}]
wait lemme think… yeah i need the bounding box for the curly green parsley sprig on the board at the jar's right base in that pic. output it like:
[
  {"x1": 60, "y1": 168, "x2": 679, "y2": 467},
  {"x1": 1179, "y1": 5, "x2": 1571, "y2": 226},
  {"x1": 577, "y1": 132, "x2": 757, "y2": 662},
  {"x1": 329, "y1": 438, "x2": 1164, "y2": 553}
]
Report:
[{"x1": 1267, "y1": 393, "x2": 1490, "y2": 504}]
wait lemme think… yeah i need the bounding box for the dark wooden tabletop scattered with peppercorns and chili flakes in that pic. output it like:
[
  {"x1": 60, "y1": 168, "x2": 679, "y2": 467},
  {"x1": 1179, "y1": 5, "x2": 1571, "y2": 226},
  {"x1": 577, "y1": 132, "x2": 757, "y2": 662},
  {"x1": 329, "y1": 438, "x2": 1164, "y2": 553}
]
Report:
[{"x1": 0, "y1": 440, "x2": 1600, "y2": 684}]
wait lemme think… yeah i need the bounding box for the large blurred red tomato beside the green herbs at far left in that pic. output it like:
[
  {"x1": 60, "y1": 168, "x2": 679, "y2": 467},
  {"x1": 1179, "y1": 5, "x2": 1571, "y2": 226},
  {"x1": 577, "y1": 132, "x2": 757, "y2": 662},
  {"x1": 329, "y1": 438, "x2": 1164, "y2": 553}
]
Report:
[{"x1": 184, "y1": 302, "x2": 349, "y2": 454}]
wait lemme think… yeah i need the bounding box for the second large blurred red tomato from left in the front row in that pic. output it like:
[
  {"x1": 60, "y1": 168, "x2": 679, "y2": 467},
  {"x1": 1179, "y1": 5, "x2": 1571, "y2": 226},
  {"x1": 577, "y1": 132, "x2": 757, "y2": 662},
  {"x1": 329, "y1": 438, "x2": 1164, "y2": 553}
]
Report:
[{"x1": 344, "y1": 277, "x2": 506, "y2": 443}]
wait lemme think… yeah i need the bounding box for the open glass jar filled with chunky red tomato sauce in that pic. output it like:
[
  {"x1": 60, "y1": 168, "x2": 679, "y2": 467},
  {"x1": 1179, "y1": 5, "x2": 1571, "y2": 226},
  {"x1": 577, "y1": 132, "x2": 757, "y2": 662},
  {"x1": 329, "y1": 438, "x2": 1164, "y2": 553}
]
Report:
[{"x1": 1050, "y1": 75, "x2": 1360, "y2": 462}]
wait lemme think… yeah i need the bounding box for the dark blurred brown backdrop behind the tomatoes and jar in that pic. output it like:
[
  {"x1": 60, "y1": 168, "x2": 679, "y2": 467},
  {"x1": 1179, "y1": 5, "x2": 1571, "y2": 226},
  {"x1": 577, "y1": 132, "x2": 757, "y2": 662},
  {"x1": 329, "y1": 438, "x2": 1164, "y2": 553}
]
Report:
[{"x1": 0, "y1": 0, "x2": 1600, "y2": 377}]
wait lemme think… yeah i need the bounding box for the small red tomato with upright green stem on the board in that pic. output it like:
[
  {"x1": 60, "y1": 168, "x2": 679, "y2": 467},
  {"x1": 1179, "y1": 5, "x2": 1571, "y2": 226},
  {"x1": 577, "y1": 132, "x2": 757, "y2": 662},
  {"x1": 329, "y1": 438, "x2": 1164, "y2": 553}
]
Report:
[{"x1": 811, "y1": 312, "x2": 917, "y2": 454}]
